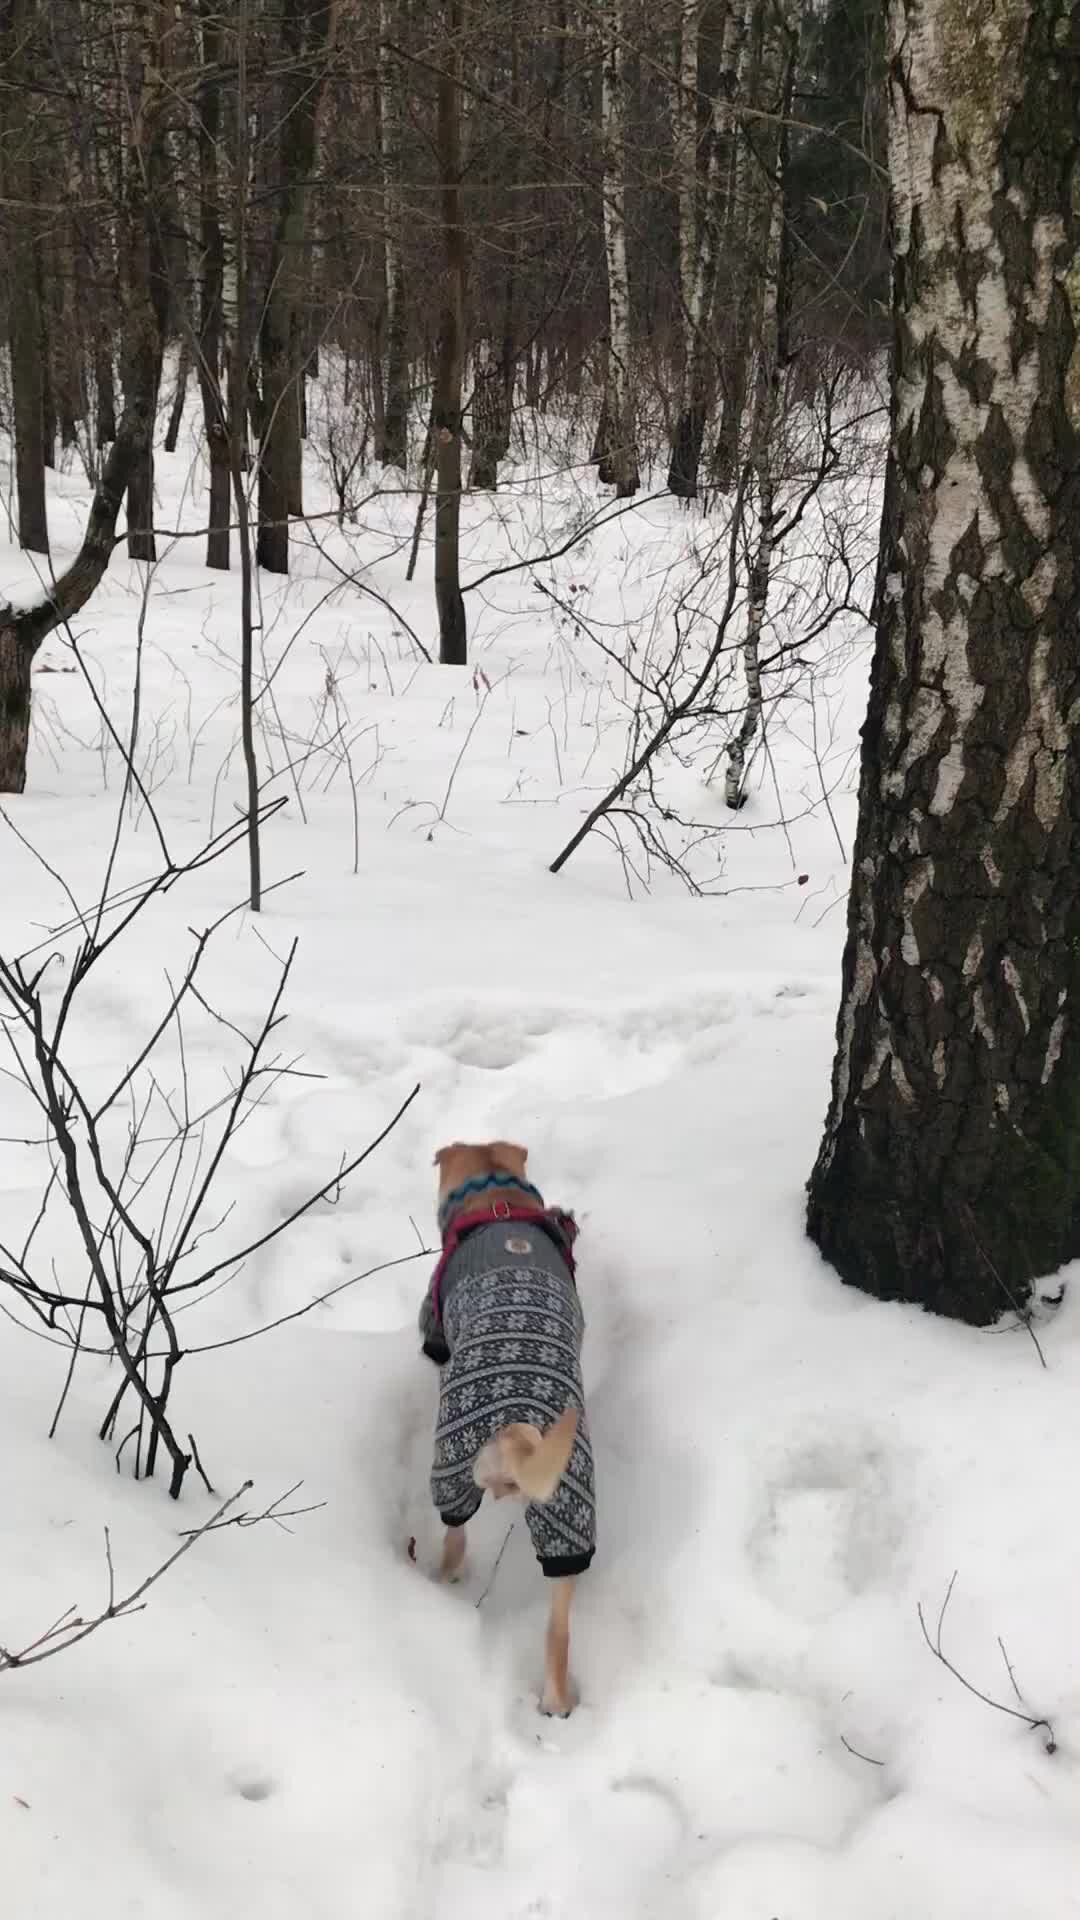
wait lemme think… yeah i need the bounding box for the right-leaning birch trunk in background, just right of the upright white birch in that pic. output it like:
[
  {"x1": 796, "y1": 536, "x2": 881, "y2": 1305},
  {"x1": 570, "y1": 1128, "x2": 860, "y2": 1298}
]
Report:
[{"x1": 667, "y1": 0, "x2": 748, "y2": 499}]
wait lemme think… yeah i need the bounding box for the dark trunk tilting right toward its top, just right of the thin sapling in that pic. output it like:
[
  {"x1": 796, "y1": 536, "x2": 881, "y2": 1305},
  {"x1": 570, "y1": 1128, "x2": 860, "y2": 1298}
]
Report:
[{"x1": 258, "y1": 0, "x2": 332, "y2": 574}]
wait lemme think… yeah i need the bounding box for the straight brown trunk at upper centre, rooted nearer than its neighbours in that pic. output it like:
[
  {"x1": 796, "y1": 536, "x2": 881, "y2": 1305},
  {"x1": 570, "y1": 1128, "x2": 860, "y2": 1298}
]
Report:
[{"x1": 432, "y1": 0, "x2": 467, "y2": 666}]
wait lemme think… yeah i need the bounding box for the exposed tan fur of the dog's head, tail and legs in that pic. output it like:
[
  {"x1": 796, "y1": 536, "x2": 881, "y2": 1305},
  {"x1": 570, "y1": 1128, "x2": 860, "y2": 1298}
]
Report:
[{"x1": 434, "y1": 1140, "x2": 578, "y2": 1718}]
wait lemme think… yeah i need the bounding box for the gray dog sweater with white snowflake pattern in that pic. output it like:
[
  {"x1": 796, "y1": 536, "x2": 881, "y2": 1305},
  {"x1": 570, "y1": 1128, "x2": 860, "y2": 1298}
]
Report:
[{"x1": 419, "y1": 1219, "x2": 596, "y2": 1578}]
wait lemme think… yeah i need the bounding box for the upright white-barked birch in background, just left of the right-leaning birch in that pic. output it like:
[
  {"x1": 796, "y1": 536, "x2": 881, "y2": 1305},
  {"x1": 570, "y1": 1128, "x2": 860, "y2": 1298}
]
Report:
[{"x1": 600, "y1": 0, "x2": 640, "y2": 499}]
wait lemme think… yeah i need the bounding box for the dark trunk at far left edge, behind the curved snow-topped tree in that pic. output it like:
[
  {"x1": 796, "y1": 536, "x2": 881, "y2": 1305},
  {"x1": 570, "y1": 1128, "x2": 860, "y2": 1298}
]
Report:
[{"x1": 0, "y1": 0, "x2": 48, "y2": 560}]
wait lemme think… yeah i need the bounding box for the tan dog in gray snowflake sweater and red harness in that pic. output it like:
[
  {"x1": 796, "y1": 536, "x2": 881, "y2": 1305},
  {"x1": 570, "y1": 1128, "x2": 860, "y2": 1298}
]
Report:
[{"x1": 419, "y1": 1140, "x2": 596, "y2": 1718}]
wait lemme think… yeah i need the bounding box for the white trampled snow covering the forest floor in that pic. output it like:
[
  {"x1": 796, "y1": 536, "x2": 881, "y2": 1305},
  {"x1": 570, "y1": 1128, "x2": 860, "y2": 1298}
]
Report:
[{"x1": 0, "y1": 393, "x2": 1080, "y2": 1920}]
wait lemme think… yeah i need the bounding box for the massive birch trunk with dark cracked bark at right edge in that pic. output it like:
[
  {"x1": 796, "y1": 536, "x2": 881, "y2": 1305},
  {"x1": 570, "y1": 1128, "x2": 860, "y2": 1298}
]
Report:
[{"x1": 809, "y1": 0, "x2": 1080, "y2": 1325}]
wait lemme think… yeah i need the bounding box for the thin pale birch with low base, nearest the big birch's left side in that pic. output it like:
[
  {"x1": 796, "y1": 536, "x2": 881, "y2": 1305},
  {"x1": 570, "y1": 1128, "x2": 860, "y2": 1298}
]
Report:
[{"x1": 724, "y1": 0, "x2": 799, "y2": 808}]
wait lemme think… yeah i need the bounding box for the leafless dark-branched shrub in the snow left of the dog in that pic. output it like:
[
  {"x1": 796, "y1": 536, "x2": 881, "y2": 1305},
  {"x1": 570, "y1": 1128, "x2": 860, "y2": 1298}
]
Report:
[{"x1": 0, "y1": 803, "x2": 411, "y2": 1498}]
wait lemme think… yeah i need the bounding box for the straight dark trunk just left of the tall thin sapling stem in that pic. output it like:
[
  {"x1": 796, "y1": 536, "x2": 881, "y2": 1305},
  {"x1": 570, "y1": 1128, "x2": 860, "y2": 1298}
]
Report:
[{"x1": 196, "y1": 0, "x2": 228, "y2": 572}]
